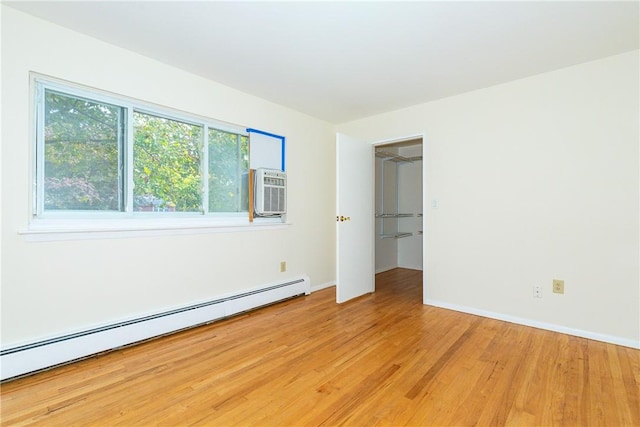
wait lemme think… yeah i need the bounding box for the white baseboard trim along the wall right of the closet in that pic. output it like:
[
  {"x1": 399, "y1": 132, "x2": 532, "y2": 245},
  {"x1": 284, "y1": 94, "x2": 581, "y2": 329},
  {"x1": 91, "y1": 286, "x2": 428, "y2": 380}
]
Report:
[{"x1": 424, "y1": 299, "x2": 640, "y2": 349}]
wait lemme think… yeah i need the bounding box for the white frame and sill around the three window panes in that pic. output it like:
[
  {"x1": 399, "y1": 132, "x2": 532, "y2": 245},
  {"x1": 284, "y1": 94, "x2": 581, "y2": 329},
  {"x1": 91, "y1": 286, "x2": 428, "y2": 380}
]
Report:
[{"x1": 25, "y1": 73, "x2": 285, "y2": 240}]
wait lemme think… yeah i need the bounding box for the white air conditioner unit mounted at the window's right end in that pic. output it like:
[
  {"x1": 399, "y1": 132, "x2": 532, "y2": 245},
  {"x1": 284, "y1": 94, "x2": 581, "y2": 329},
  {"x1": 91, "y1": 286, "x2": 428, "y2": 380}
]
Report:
[{"x1": 254, "y1": 169, "x2": 287, "y2": 216}]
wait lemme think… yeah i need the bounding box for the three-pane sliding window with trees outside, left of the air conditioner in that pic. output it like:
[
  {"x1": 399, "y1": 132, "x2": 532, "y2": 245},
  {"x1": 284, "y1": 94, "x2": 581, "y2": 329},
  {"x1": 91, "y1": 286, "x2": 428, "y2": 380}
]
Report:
[{"x1": 35, "y1": 79, "x2": 249, "y2": 218}]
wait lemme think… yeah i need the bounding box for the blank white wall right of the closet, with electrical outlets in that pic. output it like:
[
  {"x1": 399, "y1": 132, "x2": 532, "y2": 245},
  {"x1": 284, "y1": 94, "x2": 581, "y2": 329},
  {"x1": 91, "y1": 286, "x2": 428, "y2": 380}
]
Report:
[{"x1": 339, "y1": 51, "x2": 640, "y2": 346}]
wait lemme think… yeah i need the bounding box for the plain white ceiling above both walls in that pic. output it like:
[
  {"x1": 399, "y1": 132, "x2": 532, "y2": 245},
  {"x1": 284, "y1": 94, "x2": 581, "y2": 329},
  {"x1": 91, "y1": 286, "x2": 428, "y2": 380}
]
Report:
[{"x1": 4, "y1": 1, "x2": 640, "y2": 123}]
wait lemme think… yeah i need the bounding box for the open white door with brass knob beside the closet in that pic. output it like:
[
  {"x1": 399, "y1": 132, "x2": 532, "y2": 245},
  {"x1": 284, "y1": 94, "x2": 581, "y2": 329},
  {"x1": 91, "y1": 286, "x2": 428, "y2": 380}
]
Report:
[{"x1": 336, "y1": 133, "x2": 375, "y2": 303}]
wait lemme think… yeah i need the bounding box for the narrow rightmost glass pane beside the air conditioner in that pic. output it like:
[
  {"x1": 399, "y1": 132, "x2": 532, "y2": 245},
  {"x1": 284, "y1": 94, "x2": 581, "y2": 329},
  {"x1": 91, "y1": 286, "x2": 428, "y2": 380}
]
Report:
[{"x1": 209, "y1": 129, "x2": 249, "y2": 212}]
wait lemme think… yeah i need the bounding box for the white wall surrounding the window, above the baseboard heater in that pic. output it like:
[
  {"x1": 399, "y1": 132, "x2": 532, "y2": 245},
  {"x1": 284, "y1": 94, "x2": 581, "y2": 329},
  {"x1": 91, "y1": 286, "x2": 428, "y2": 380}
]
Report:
[{"x1": 1, "y1": 5, "x2": 335, "y2": 348}]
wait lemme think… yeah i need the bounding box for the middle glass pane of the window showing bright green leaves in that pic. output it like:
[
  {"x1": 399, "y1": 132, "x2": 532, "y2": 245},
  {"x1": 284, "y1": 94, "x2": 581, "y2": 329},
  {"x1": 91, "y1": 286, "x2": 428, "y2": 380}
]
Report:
[{"x1": 133, "y1": 112, "x2": 203, "y2": 212}]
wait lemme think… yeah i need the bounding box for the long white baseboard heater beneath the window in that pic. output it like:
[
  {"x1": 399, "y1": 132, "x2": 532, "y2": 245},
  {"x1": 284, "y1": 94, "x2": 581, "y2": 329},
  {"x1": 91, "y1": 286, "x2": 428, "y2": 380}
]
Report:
[{"x1": 0, "y1": 276, "x2": 311, "y2": 381}]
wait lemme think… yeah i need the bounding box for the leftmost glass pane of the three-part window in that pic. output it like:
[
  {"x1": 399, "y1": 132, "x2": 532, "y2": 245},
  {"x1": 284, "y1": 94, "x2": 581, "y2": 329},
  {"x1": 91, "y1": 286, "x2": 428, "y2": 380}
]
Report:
[{"x1": 44, "y1": 90, "x2": 125, "y2": 211}]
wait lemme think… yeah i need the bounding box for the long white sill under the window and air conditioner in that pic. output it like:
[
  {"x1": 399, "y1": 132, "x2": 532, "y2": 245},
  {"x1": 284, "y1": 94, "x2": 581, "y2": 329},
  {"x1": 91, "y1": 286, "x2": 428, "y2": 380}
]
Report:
[{"x1": 18, "y1": 217, "x2": 291, "y2": 242}]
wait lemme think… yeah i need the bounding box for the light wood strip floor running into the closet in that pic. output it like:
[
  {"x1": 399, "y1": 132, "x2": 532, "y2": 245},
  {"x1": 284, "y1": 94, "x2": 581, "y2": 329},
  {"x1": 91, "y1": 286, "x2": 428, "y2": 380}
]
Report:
[{"x1": 0, "y1": 269, "x2": 640, "y2": 426}]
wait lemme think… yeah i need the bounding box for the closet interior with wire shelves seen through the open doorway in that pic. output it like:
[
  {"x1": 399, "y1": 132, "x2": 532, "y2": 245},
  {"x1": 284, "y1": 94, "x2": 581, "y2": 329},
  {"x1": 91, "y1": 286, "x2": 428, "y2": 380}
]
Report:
[{"x1": 374, "y1": 137, "x2": 423, "y2": 290}]
